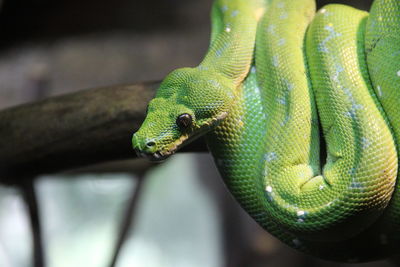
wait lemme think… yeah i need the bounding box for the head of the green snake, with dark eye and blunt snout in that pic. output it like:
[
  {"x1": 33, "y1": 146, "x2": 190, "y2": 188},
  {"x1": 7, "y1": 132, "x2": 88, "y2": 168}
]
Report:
[{"x1": 132, "y1": 68, "x2": 235, "y2": 161}]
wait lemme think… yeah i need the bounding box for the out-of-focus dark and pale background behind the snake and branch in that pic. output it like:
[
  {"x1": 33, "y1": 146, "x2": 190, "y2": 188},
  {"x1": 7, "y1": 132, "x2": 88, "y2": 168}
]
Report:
[{"x1": 0, "y1": 0, "x2": 395, "y2": 267}]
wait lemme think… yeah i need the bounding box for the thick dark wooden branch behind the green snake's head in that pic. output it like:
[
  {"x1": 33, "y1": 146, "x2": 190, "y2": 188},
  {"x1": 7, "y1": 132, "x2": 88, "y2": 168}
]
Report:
[{"x1": 0, "y1": 82, "x2": 206, "y2": 183}]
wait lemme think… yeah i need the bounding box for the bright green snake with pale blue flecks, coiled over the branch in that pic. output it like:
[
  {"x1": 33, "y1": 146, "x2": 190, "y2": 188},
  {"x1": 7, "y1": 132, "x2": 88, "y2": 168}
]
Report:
[{"x1": 132, "y1": 0, "x2": 400, "y2": 262}]
